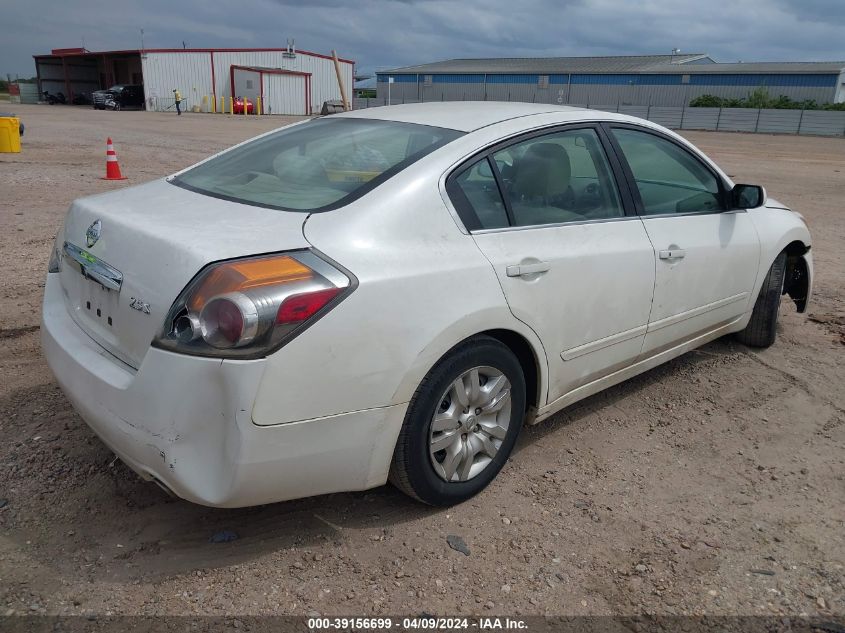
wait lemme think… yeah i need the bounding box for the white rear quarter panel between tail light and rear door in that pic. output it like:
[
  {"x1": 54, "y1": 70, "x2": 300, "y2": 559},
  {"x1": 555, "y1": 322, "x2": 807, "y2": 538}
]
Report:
[{"x1": 253, "y1": 152, "x2": 546, "y2": 425}]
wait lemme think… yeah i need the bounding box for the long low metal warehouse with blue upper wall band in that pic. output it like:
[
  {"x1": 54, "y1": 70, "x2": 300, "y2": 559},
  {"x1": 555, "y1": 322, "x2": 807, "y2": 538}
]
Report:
[{"x1": 377, "y1": 53, "x2": 845, "y2": 106}]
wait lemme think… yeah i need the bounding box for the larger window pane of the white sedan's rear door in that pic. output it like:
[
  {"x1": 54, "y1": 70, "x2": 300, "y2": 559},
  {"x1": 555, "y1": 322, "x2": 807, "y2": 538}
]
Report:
[{"x1": 493, "y1": 128, "x2": 624, "y2": 226}]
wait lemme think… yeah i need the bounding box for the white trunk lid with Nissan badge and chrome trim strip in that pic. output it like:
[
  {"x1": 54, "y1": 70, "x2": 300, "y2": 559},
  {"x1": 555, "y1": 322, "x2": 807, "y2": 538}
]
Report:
[{"x1": 59, "y1": 180, "x2": 308, "y2": 368}]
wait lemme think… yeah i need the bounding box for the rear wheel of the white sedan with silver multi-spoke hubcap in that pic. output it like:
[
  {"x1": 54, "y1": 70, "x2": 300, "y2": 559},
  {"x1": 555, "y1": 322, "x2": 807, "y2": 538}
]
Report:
[{"x1": 389, "y1": 336, "x2": 525, "y2": 506}]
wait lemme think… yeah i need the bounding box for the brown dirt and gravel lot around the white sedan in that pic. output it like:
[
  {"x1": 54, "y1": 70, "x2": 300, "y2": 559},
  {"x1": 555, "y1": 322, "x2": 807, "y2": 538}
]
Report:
[{"x1": 0, "y1": 106, "x2": 845, "y2": 617}]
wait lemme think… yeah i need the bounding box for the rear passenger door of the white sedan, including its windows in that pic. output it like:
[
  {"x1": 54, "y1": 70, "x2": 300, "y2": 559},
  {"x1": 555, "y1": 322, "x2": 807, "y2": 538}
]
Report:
[{"x1": 447, "y1": 125, "x2": 654, "y2": 402}]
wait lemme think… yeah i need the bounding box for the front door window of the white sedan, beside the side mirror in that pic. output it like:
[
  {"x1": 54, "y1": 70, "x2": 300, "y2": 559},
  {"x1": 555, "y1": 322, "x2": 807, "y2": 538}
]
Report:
[{"x1": 613, "y1": 128, "x2": 723, "y2": 215}]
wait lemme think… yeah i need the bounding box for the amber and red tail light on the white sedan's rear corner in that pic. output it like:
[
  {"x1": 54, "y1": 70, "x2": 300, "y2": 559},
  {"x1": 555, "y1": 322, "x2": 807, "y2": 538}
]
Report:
[{"x1": 154, "y1": 251, "x2": 352, "y2": 358}]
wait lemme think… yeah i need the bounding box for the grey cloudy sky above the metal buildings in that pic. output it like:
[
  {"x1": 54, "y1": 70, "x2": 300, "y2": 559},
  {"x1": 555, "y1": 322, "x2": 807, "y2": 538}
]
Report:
[{"x1": 0, "y1": 0, "x2": 845, "y2": 76}]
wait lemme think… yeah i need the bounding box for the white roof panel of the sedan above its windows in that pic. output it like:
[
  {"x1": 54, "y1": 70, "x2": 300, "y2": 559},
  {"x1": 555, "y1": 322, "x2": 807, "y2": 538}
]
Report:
[{"x1": 332, "y1": 101, "x2": 607, "y2": 132}]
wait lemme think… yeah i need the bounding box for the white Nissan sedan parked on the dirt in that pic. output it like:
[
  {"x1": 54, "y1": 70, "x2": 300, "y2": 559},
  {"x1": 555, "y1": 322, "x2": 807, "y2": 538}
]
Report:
[{"x1": 41, "y1": 102, "x2": 813, "y2": 507}]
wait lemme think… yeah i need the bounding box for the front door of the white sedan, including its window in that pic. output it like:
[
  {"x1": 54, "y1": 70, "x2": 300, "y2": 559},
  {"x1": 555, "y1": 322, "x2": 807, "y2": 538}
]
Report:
[{"x1": 608, "y1": 124, "x2": 760, "y2": 356}]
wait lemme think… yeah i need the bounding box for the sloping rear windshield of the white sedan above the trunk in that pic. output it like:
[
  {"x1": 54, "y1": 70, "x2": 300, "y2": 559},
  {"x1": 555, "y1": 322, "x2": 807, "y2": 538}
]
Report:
[{"x1": 172, "y1": 117, "x2": 463, "y2": 212}]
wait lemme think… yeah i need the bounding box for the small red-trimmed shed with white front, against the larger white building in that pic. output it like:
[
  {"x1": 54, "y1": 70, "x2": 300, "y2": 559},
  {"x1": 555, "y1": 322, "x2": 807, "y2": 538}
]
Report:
[{"x1": 229, "y1": 65, "x2": 311, "y2": 115}]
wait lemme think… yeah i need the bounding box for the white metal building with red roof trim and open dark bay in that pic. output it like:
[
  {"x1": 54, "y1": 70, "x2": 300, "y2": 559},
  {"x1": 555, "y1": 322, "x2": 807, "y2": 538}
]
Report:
[{"x1": 33, "y1": 48, "x2": 355, "y2": 114}]
